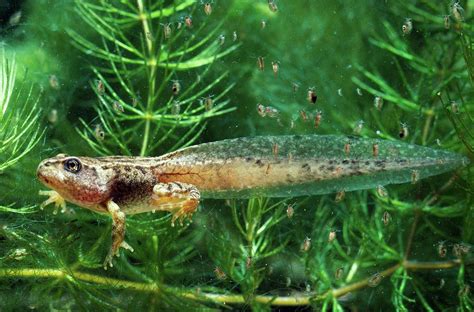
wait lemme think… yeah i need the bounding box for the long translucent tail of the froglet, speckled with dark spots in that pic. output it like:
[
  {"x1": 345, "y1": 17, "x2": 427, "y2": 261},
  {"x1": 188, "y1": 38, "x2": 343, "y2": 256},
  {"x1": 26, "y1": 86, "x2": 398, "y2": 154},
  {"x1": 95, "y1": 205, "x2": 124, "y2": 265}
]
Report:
[{"x1": 157, "y1": 135, "x2": 469, "y2": 198}]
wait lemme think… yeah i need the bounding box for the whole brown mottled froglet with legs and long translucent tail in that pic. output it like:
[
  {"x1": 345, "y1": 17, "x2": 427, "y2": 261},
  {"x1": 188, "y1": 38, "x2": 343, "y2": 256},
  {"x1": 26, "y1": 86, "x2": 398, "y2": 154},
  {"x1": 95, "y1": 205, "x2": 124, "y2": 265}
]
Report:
[{"x1": 37, "y1": 135, "x2": 468, "y2": 267}]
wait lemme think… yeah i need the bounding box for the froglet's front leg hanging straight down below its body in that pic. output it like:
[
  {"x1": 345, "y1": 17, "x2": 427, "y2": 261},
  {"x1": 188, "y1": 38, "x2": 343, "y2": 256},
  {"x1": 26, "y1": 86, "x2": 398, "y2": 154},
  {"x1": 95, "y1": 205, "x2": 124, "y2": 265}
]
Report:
[{"x1": 104, "y1": 200, "x2": 133, "y2": 270}]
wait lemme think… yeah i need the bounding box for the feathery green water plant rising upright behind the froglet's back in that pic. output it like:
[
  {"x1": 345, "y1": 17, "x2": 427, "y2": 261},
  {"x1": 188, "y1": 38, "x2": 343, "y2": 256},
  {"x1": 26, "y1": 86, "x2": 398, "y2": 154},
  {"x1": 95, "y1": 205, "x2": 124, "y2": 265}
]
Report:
[{"x1": 68, "y1": 0, "x2": 238, "y2": 156}]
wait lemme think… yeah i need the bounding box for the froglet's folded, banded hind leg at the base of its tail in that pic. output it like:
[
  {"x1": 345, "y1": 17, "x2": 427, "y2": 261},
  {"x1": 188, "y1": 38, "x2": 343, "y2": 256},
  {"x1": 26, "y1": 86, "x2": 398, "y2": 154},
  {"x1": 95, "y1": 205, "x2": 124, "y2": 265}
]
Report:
[{"x1": 151, "y1": 182, "x2": 201, "y2": 226}]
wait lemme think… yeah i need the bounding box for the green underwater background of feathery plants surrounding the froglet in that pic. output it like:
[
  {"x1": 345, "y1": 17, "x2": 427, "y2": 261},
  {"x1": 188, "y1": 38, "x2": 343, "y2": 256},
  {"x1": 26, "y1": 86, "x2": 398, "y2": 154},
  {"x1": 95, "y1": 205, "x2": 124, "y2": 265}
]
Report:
[{"x1": 0, "y1": 0, "x2": 474, "y2": 311}]
